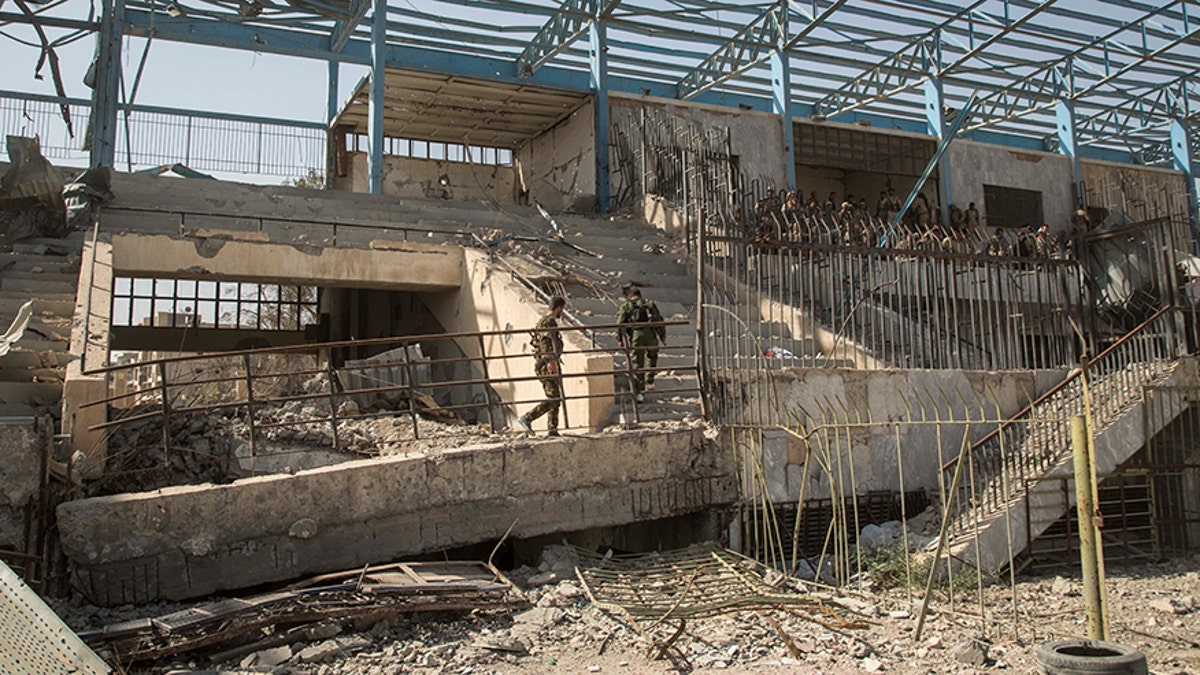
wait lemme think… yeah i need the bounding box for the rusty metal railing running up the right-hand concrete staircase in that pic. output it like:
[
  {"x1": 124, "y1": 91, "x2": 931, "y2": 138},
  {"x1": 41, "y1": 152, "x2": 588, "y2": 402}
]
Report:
[{"x1": 941, "y1": 307, "x2": 1190, "y2": 547}]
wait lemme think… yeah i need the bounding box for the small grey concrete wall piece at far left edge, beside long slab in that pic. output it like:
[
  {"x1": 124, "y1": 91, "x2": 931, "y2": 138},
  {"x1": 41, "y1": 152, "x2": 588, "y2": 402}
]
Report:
[{"x1": 0, "y1": 417, "x2": 42, "y2": 551}]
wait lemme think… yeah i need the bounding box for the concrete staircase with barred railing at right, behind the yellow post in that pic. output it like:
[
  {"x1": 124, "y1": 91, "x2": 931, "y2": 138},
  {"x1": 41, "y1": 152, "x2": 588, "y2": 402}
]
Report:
[{"x1": 946, "y1": 326, "x2": 1200, "y2": 573}]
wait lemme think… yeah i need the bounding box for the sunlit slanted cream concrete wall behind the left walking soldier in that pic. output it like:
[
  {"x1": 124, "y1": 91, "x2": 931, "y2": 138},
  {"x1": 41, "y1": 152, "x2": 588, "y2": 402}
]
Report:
[{"x1": 424, "y1": 250, "x2": 613, "y2": 429}]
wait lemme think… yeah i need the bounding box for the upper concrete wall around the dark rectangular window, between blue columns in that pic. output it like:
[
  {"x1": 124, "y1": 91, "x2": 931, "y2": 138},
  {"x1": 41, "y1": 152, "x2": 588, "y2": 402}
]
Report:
[{"x1": 950, "y1": 141, "x2": 1075, "y2": 232}]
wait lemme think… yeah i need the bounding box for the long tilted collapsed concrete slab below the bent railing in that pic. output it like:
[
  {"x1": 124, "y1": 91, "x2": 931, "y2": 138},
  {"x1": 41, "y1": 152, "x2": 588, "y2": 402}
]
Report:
[{"x1": 58, "y1": 430, "x2": 737, "y2": 605}]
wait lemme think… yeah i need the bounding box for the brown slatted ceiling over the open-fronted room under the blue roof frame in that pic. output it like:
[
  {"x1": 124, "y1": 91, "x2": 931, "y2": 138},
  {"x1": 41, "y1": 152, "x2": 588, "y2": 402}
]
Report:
[{"x1": 334, "y1": 68, "x2": 590, "y2": 148}]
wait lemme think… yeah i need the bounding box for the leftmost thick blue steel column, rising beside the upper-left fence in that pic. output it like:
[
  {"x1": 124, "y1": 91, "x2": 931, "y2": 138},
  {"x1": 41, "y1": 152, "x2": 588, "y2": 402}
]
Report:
[{"x1": 88, "y1": 0, "x2": 125, "y2": 167}]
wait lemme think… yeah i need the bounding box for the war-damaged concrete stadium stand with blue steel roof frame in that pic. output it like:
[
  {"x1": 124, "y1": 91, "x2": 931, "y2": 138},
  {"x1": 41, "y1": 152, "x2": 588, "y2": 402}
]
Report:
[{"x1": 0, "y1": 0, "x2": 1200, "y2": 667}]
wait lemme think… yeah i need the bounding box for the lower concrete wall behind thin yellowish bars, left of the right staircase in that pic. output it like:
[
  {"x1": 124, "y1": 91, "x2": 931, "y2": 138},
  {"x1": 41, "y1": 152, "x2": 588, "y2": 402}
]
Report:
[{"x1": 748, "y1": 369, "x2": 1066, "y2": 502}]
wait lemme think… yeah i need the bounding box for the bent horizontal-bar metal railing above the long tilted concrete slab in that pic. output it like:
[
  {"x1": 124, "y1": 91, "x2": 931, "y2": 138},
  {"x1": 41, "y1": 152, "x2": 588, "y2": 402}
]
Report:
[{"x1": 80, "y1": 322, "x2": 697, "y2": 492}]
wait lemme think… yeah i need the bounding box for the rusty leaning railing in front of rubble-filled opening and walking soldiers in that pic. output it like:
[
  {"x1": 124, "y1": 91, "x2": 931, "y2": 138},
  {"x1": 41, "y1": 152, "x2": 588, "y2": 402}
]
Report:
[{"x1": 79, "y1": 321, "x2": 700, "y2": 487}]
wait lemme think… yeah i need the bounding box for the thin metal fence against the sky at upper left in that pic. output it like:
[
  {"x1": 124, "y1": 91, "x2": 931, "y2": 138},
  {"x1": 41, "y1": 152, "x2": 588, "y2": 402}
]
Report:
[{"x1": 0, "y1": 91, "x2": 326, "y2": 178}]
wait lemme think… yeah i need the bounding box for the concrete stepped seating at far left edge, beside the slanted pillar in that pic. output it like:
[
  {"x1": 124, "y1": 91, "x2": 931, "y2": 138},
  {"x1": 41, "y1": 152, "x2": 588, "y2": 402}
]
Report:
[{"x1": 0, "y1": 232, "x2": 84, "y2": 414}]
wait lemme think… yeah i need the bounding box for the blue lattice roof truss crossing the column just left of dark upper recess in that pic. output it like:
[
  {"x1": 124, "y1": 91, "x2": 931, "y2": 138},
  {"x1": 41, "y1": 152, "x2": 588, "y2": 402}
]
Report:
[{"x1": 677, "y1": 0, "x2": 847, "y2": 101}]
